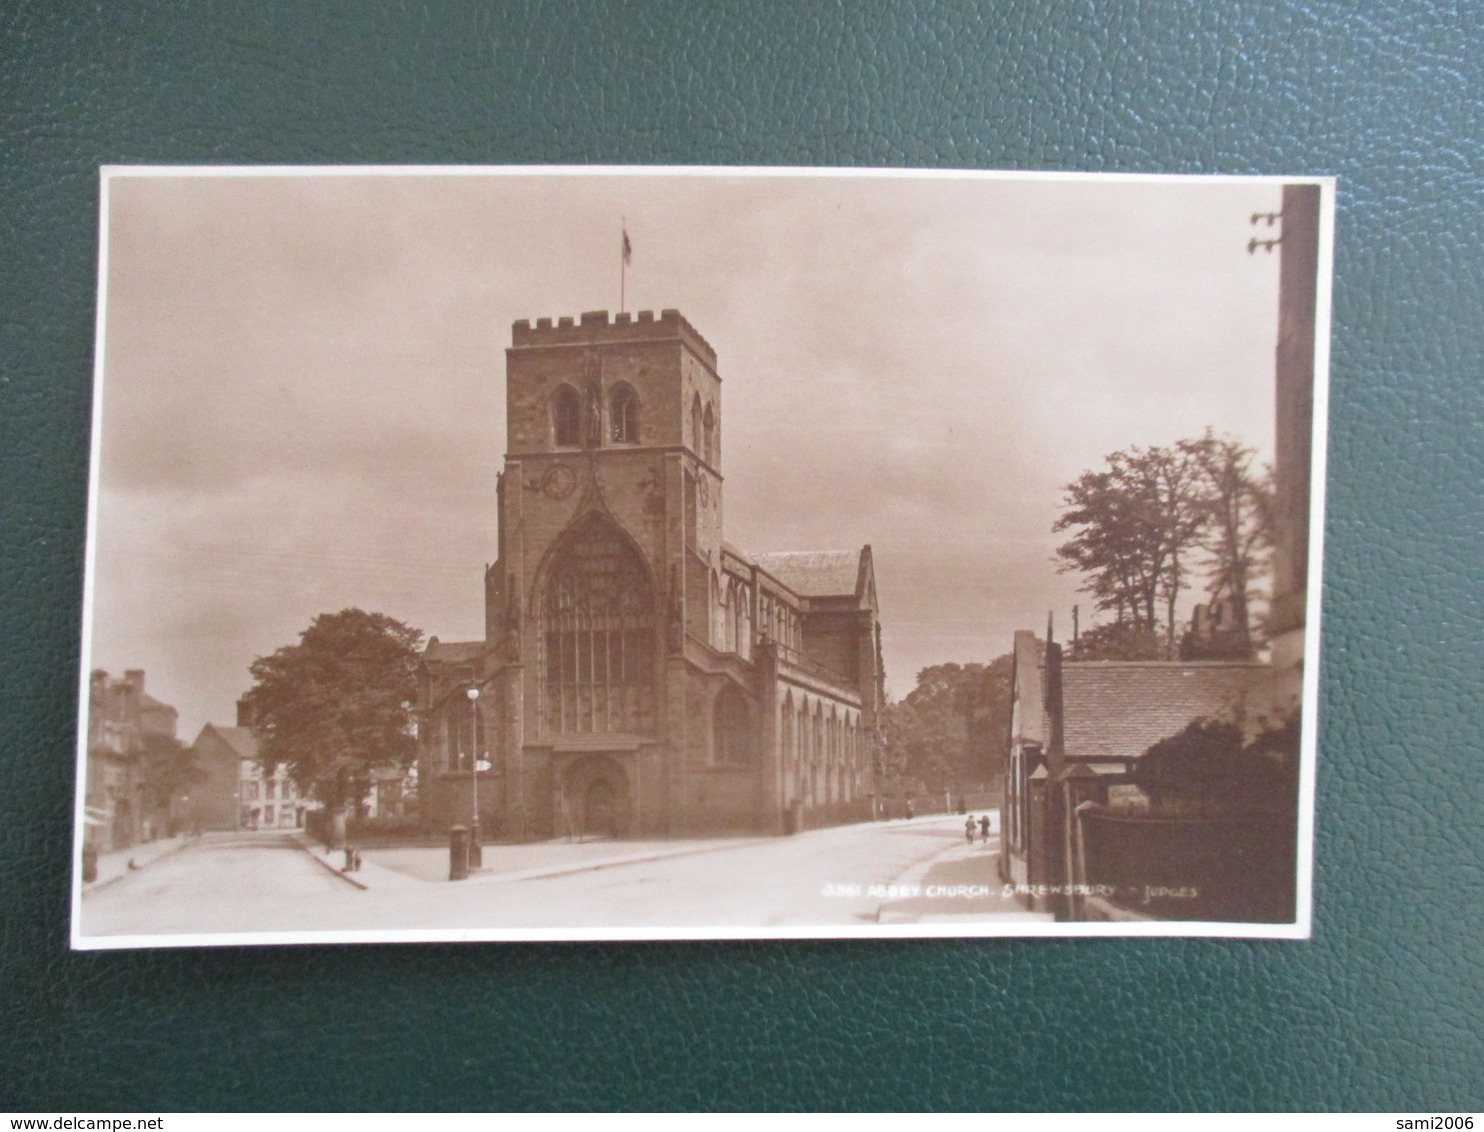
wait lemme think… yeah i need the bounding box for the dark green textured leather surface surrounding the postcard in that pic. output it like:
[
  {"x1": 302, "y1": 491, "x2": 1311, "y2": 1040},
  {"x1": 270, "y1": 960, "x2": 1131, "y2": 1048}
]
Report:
[{"x1": 0, "y1": 0, "x2": 1484, "y2": 1111}]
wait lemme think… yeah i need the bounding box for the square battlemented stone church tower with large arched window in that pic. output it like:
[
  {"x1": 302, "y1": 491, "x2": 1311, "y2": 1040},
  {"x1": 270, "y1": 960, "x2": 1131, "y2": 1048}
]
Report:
[{"x1": 485, "y1": 310, "x2": 721, "y2": 832}]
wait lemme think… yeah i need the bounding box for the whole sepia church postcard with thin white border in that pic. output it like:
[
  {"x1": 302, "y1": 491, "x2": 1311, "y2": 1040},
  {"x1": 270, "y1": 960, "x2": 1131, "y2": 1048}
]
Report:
[{"x1": 73, "y1": 168, "x2": 1334, "y2": 948}]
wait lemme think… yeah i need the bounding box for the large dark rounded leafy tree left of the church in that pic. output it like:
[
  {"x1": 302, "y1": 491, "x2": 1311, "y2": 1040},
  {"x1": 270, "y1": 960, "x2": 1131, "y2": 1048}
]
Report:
[{"x1": 238, "y1": 610, "x2": 423, "y2": 813}]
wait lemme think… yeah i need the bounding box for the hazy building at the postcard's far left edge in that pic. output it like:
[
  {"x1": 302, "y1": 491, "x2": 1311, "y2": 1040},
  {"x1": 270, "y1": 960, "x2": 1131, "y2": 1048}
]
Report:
[{"x1": 85, "y1": 668, "x2": 177, "y2": 852}]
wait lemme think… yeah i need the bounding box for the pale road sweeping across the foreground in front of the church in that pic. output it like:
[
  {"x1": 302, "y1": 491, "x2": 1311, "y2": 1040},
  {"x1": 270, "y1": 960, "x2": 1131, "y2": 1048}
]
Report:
[{"x1": 83, "y1": 819, "x2": 1024, "y2": 935}]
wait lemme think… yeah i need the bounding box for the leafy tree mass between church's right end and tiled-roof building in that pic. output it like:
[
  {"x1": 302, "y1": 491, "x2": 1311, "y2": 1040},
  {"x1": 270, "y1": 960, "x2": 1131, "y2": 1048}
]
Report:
[{"x1": 883, "y1": 654, "x2": 1011, "y2": 791}]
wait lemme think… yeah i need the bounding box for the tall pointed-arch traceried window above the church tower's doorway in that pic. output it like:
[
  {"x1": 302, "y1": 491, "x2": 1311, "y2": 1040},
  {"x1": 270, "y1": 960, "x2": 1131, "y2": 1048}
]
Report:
[{"x1": 542, "y1": 515, "x2": 654, "y2": 734}]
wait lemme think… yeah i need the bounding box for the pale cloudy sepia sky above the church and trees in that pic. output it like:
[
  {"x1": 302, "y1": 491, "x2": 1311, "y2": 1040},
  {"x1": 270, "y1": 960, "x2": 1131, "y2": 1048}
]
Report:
[{"x1": 88, "y1": 171, "x2": 1281, "y2": 740}]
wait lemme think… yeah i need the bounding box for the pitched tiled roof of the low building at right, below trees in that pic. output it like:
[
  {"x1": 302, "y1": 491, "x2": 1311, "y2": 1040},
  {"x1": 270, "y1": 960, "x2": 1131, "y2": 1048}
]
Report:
[{"x1": 1061, "y1": 660, "x2": 1272, "y2": 758}]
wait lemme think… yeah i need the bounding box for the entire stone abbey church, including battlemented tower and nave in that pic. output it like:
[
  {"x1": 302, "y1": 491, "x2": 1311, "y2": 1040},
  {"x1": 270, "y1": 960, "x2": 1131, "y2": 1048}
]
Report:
[{"x1": 418, "y1": 310, "x2": 884, "y2": 840}]
